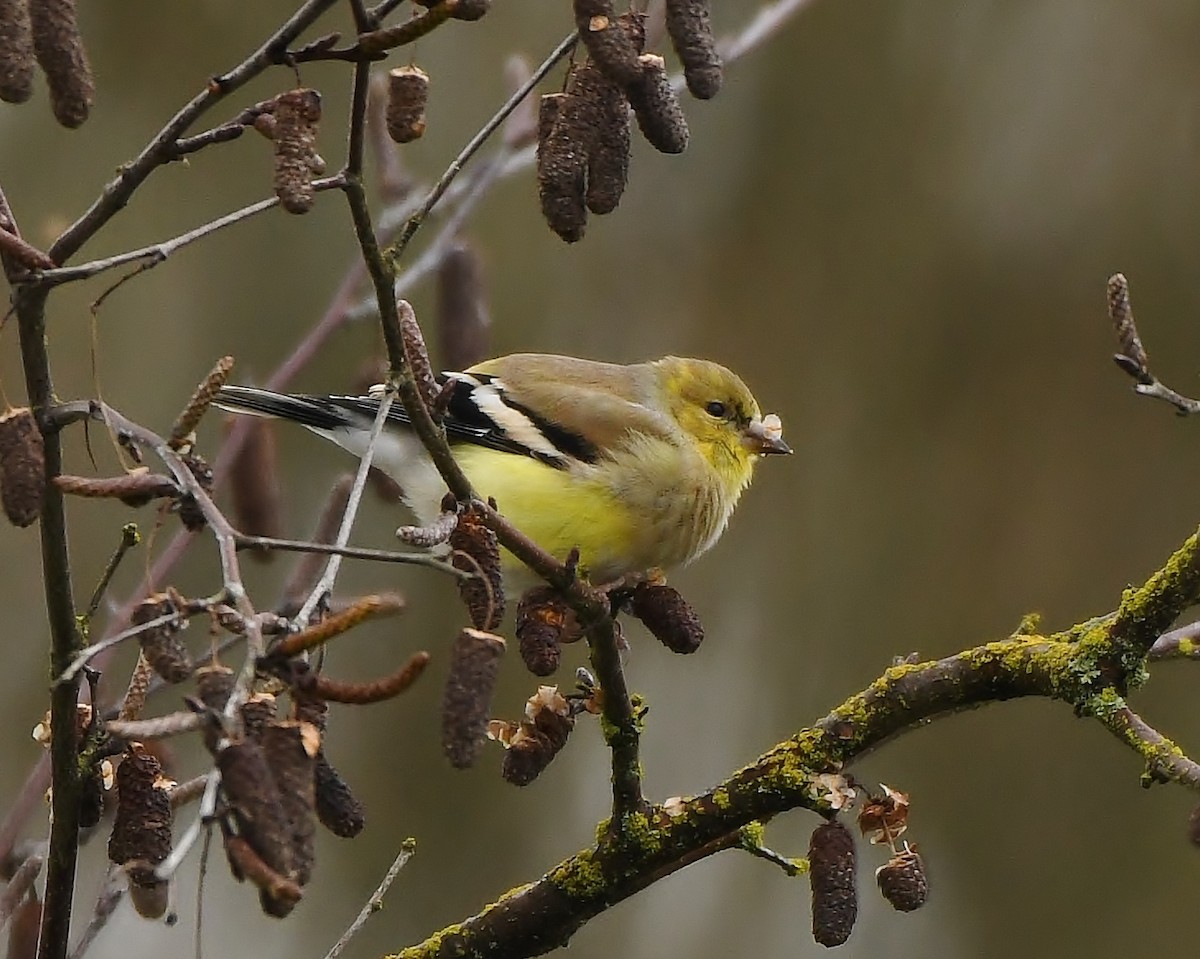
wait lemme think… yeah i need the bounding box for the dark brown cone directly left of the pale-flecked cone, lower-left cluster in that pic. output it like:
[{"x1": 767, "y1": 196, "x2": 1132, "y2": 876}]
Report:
[{"x1": 216, "y1": 739, "x2": 293, "y2": 892}]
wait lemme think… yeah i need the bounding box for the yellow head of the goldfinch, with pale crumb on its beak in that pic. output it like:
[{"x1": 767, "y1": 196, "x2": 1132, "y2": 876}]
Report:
[{"x1": 655, "y1": 356, "x2": 792, "y2": 485}]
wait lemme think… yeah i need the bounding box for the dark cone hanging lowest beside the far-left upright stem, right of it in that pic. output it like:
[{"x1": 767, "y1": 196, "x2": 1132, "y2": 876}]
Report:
[{"x1": 108, "y1": 745, "x2": 172, "y2": 902}]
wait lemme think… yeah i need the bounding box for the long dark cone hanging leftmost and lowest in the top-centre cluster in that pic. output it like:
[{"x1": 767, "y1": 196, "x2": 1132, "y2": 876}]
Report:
[{"x1": 538, "y1": 94, "x2": 590, "y2": 244}]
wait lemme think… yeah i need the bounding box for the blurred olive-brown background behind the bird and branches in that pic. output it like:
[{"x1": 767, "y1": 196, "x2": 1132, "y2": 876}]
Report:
[{"x1": 0, "y1": 0, "x2": 1200, "y2": 959}]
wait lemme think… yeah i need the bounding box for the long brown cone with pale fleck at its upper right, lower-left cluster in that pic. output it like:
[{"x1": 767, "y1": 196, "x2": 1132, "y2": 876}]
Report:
[{"x1": 262, "y1": 720, "x2": 320, "y2": 886}]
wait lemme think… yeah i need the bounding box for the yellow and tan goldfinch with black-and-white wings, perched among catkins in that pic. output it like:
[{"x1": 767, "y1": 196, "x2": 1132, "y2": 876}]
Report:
[{"x1": 216, "y1": 353, "x2": 792, "y2": 583}]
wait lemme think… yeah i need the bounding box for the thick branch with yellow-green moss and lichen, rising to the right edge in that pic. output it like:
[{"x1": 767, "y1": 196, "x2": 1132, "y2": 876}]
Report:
[{"x1": 396, "y1": 535, "x2": 1200, "y2": 959}]
